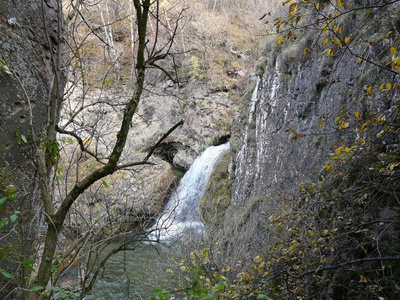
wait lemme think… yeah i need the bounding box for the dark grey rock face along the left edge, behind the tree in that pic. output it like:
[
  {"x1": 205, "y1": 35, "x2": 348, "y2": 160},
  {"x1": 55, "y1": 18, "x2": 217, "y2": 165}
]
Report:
[{"x1": 0, "y1": 0, "x2": 64, "y2": 298}]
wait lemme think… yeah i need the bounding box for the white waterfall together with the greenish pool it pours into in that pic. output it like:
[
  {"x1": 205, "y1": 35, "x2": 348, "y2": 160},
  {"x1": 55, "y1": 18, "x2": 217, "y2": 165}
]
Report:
[{"x1": 85, "y1": 144, "x2": 229, "y2": 300}]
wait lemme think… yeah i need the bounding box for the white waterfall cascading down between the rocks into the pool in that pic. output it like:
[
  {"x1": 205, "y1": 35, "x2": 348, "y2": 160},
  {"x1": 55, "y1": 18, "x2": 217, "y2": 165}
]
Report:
[{"x1": 150, "y1": 143, "x2": 229, "y2": 241}]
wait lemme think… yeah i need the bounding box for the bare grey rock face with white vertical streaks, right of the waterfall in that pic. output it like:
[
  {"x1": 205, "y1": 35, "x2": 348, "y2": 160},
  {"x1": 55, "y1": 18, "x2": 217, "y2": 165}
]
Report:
[{"x1": 225, "y1": 28, "x2": 396, "y2": 256}]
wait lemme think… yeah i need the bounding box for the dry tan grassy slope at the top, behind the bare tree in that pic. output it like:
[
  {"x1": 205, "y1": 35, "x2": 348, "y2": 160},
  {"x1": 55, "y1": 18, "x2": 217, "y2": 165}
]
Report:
[{"x1": 66, "y1": 0, "x2": 282, "y2": 88}]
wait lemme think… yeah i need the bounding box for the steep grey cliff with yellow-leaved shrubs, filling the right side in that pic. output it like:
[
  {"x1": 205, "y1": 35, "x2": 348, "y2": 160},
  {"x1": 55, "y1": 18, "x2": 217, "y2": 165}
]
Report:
[{"x1": 171, "y1": 0, "x2": 400, "y2": 299}]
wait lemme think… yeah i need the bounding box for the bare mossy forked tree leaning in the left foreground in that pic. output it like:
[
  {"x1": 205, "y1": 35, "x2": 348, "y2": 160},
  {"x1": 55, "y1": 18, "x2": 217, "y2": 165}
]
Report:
[{"x1": 19, "y1": 0, "x2": 189, "y2": 299}]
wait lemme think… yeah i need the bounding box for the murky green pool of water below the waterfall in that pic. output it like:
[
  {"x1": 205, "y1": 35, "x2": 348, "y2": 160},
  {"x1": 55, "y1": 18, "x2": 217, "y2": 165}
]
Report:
[{"x1": 85, "y1": 244, "x2": 188, "y2": 300}]
